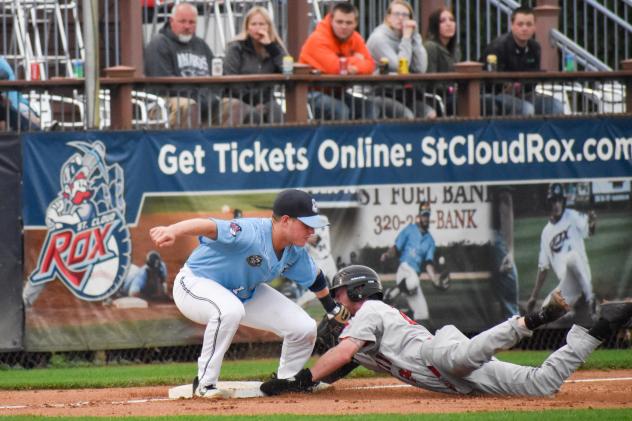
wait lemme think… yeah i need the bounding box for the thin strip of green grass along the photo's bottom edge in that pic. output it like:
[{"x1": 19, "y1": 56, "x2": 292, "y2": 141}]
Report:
[{"x1": 0, "y1": 409, "x2": 632, "y2": 421}]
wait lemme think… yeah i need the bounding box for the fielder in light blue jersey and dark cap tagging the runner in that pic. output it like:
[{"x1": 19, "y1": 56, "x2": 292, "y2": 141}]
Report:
[{"x1": 150, "y1": 189, "x2": 348, "y2": 398}]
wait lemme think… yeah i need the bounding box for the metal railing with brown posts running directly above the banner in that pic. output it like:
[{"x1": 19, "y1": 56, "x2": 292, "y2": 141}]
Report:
[{"x1": 0, "y1": 69, "x2": 632, "y2": 132}]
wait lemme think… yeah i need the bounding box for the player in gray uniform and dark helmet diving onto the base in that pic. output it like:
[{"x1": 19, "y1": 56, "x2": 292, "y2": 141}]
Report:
[{"x1": 261, "y1": 265, "x2": 632, "y2": 396}]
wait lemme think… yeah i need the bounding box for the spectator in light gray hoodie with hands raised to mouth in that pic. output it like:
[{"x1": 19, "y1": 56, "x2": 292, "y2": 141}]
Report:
[{"x1": 366, "y1": 0, "x2": 436, "y2": 117}]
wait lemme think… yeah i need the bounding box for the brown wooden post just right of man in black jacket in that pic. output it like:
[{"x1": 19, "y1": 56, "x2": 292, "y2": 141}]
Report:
[{"x1": 533, "y1": 0, "x2": 560, "y2": 72}]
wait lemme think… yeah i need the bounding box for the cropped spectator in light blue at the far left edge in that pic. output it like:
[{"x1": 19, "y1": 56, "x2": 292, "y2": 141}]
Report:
[{"x1": 0, "y1": 56, "x2": 41, "y2": 130}]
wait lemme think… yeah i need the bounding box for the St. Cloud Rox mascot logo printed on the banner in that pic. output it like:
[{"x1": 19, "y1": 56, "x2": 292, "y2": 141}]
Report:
[{"x1": 29, "y1": 141, "x2": 131, "y2": 301}]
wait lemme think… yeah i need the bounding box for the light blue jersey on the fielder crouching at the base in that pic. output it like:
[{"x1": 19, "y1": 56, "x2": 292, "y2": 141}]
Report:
[{"x1": 186, "y1": 218, "x2": 318, "y2": 301}]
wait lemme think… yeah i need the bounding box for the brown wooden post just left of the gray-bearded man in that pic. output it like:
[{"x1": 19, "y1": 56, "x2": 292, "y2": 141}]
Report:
[{"x1": 118, "y1": 0, "x2": 144, "y2": 76}]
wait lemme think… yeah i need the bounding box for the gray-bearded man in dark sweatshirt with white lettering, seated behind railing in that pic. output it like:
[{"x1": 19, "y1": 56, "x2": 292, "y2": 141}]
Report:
[{"x1": 145, "y1": 2, "x2": 242, "y2": 127}]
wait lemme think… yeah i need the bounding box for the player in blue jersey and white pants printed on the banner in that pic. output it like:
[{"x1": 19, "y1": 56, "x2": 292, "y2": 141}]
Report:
[{"x1": 381, "y1": 202, "x2": 446, "y2": 323}]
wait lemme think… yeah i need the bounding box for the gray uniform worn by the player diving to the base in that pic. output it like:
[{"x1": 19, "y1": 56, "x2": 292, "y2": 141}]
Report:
[{"x1": 340, "y1": 300, "x2": 601, "y2": 396}]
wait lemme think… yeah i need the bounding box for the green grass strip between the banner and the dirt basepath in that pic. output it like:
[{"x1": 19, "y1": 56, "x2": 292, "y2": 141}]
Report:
[{"x1": 0, "y1": 350, "x2": 632, "y2": 390}]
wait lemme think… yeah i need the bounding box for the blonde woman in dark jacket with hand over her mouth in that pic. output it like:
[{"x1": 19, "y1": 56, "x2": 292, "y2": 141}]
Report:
[{"x1": 224, "y1": 6, "x2": 286, "y2": 123}]
